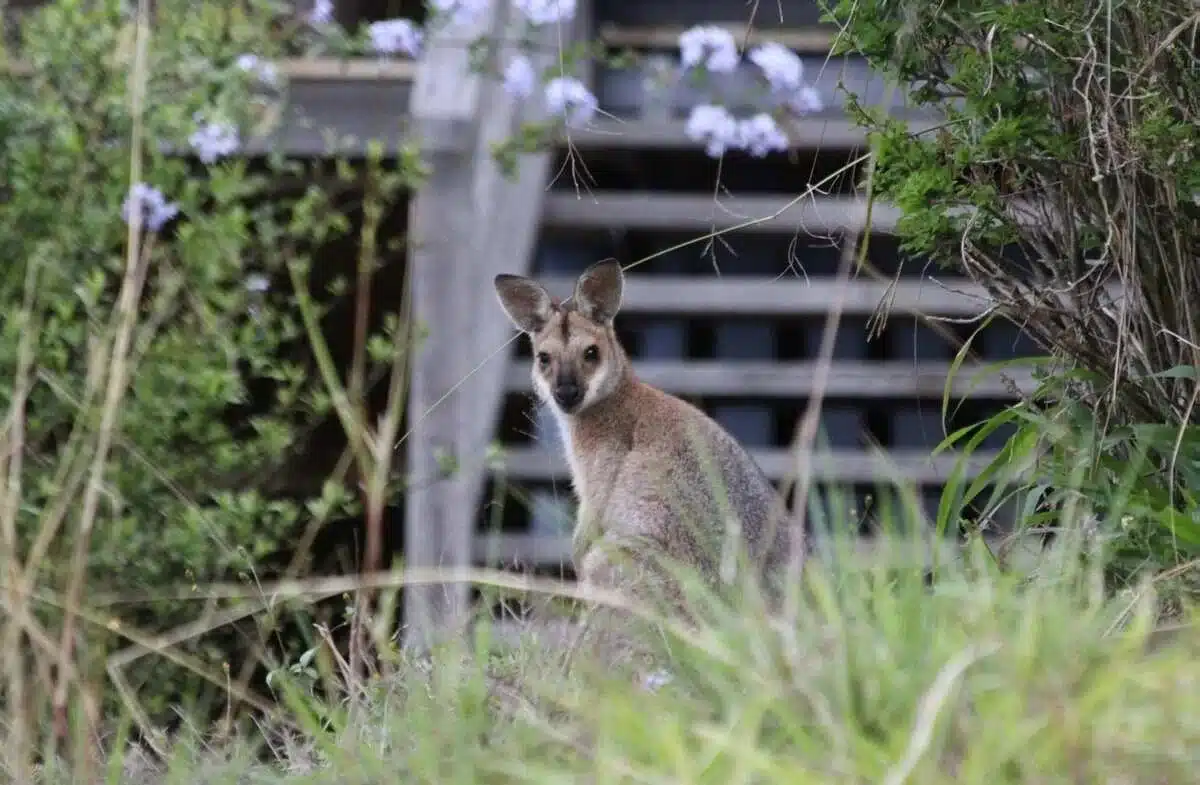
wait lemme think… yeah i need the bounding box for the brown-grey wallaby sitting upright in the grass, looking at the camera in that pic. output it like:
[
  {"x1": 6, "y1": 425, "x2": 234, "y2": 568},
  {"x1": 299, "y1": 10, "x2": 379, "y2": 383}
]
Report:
[{"x1": 494, "y1": 259, "x2": 803, "y2": 604}]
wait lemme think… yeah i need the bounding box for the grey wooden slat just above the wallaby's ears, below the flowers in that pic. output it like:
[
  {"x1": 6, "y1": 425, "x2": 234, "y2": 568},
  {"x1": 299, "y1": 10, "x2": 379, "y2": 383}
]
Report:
[{"x1": 542, "y1": 191, "x2": 900, "y2": 234}]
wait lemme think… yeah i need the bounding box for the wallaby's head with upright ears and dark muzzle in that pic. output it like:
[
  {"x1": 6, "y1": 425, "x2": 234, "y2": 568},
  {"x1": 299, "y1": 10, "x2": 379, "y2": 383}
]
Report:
[{"x1": 496, "y1": 259, "x2": 629, "y2": 414}]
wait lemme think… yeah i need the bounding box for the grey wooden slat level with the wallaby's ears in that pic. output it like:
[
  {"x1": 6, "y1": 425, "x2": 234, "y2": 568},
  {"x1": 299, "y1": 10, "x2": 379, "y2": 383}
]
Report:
[{"x1": 542, "y1": 274, "x2": 991, "y2": 317}]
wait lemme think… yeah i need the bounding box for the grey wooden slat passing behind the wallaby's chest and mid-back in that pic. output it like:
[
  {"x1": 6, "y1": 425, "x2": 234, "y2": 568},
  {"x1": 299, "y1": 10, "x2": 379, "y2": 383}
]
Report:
[{"x1": 504, "y1": 447, "x2": 997, "y2": 485}]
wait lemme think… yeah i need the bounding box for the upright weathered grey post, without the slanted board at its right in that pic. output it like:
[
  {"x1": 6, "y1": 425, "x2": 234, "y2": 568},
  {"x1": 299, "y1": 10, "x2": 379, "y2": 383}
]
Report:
[{"x1": 403, "y1": 6, "x2": 502, "y2": 649}]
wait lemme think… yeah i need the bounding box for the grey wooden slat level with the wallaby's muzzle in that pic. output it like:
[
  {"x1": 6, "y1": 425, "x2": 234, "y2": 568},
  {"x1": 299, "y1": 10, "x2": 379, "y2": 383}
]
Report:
[{"x1": 508, "y1": 360, "x2": 1033, "y2": 400}]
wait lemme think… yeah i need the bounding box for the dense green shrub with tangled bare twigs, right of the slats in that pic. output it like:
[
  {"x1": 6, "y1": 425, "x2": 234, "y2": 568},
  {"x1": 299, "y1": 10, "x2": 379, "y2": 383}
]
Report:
[{"x1": 828, "y1": 0, "x2": 1200, "y2": 590}]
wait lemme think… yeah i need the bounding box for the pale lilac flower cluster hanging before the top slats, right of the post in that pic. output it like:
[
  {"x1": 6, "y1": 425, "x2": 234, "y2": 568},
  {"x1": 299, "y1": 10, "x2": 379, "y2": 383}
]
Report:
[{"x1": 679, "y1": 25, "x2": 823, "y2": 157}]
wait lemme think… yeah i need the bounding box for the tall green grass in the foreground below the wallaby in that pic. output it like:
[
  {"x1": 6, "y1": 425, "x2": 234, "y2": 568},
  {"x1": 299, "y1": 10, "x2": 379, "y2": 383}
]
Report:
[{"x1": 5, "y1": 513, "x2": 1200, "y2": 785}]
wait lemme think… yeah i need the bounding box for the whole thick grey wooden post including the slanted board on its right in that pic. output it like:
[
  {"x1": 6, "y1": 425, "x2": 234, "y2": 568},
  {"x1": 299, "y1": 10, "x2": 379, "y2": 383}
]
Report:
[{"x1": 404, "y1": 4, "x2": 548, "y2": 649}]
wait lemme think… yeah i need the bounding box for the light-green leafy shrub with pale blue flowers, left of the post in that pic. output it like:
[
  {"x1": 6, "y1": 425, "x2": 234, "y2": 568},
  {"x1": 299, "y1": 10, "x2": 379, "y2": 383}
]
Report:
[{"x1": 0, "y1": 0, "x2": 412, "y2": 724}]
